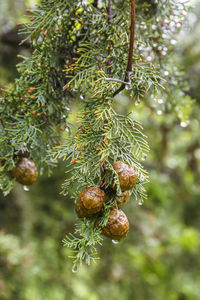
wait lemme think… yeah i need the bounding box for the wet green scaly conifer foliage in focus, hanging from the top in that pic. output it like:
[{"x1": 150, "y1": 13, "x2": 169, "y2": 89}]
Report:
[{"x1": 0, "y1": 0, "x2": 196, "y2": 265}]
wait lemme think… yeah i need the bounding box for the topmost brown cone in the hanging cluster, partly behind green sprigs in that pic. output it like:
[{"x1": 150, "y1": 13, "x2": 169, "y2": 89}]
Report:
[{"x1": 112, "y1": 161, "x2": 137, "y2": 191}]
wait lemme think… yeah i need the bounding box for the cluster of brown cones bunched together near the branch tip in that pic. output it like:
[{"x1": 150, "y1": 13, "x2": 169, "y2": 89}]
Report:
[{"x1": 76, "y1": 161, "x2": 137, "y2": 240}]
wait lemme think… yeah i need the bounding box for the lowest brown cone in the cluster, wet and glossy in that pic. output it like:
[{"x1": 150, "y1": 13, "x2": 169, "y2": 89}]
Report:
[{"x1": 102, "y1": 208, "x2": 129, "y2": 240}]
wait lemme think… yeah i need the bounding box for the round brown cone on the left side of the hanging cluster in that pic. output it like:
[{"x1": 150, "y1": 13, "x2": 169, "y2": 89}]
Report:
[{"x1": 76, "y1": 187, "x2": 106, "y2": 218}]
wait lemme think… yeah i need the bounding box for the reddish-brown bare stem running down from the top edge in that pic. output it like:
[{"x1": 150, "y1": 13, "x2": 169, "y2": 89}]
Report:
[{"x1": 113, "y1": 0, "x2": 135, "y2": 96}]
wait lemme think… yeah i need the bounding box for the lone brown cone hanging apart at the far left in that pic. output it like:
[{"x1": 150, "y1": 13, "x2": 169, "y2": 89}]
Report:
[{"x1": 11, "y1": 157, "x2": 38, "y2": 185}]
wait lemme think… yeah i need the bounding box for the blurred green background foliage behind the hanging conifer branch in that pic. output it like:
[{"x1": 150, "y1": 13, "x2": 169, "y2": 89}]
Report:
[{"x1": 0, "y1": 0, "x2": 200, "y2": 300}]
